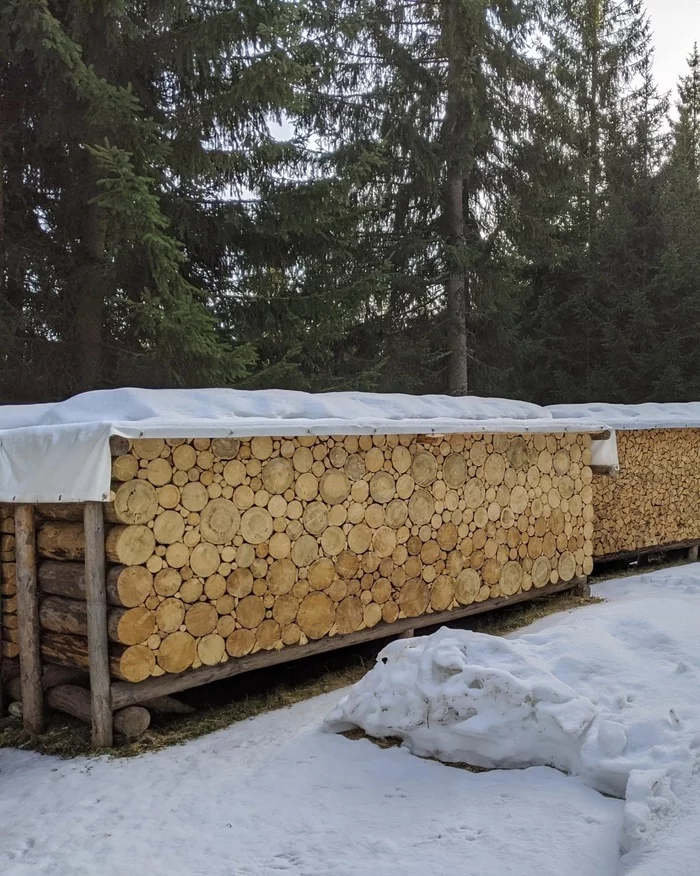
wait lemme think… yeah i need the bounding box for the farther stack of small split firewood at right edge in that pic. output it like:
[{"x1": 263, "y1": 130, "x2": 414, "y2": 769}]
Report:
[{"x1": 593, "y1": 429, "x2": 700, "y2": 557}]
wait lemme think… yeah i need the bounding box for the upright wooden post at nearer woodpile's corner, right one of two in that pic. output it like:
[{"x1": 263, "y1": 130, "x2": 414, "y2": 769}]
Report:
[{"x1": 84, "y1": 502, "x2": 112, "y2": 748}]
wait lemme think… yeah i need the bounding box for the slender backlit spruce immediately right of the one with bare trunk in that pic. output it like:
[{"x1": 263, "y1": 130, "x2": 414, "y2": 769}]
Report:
[{"x1": 516, "y1": 0, "x2": 659, "y2": 401}]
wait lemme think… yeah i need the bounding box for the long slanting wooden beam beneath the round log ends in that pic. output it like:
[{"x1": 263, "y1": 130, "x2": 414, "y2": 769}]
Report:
[{"x1": 112, "y1": 578, "x2": 587, "y2": 709}]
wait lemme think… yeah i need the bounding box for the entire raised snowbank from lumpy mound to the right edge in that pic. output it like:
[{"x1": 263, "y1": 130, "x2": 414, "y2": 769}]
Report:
[{"x1": 326, "y1": 592, "x2": 700, "y2": 851}]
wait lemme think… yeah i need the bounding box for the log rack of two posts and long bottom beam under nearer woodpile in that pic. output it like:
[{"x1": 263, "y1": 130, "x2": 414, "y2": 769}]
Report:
[{"x1": 0, "y1": 502, "x2": 588, "y2": 749}]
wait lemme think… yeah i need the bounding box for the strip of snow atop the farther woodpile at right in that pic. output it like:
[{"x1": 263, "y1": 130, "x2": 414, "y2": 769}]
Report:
[{"x1": 546, "y1": 402, "x2": 700, "y2": 431}]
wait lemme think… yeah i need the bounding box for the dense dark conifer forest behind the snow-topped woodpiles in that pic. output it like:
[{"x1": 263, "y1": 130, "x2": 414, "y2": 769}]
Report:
[{"x1": 0, "y1": 0, "x2": 700, "y2": 404}]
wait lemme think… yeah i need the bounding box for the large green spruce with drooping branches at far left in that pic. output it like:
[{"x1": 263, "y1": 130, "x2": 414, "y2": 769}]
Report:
[{"x1": 0, "y1": 0, "x2": 311, "y2": 399}]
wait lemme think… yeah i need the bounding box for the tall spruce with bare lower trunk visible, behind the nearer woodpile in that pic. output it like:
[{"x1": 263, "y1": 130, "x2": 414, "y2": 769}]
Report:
[{"x1": 296, "y1": 0, "x2": 532, "y2": 393}]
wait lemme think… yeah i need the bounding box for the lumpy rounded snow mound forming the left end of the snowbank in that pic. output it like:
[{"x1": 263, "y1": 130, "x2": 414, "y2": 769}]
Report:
[{"x1": 326, "y1": 628, "x2": 597, "y2": 772}]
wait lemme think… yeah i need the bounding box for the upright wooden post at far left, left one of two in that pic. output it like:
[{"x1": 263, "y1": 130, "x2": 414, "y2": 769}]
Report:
[{"x1": 15, "y1": 505, "x2": 44, "y2": 736}]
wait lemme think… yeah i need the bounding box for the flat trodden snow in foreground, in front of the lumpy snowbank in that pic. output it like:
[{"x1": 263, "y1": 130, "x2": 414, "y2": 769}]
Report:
[{"x1": 0, "y1": 693, "x2": 622, "y2": 876}]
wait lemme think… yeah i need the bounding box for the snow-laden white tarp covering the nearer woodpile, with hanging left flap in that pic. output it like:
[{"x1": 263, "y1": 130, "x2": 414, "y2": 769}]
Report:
[{"x1": 0, "y1": 389, "x2": 602, "y2": 502}]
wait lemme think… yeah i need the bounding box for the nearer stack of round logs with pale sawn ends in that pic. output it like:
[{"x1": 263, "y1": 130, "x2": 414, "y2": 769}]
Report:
[{"x1": 24, "y1": 434, "x2": 593, "y2": 681}]
